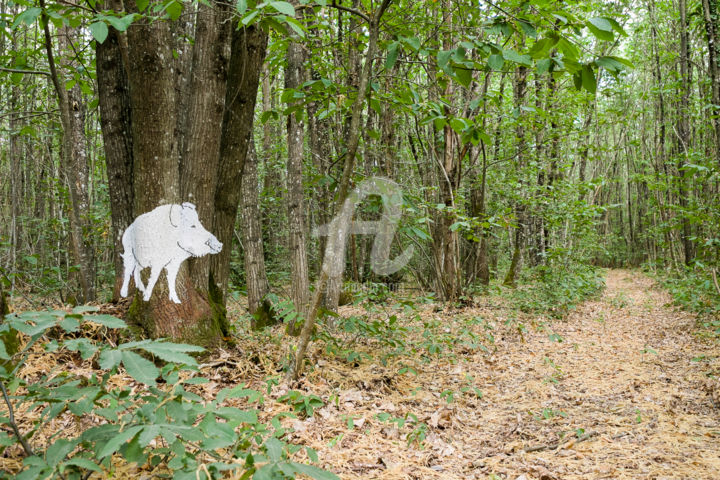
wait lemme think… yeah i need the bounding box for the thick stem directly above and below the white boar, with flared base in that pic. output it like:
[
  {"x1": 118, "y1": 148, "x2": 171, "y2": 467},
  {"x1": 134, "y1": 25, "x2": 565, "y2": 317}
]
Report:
[{"x1": 122, "y1": 2, "x2": 224, "y2": 345}]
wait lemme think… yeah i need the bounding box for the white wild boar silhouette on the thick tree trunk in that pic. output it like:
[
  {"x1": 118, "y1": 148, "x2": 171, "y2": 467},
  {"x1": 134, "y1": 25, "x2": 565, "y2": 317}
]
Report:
[{"x1": 120, "y1": 202, "x2": 222, "y2": 303}]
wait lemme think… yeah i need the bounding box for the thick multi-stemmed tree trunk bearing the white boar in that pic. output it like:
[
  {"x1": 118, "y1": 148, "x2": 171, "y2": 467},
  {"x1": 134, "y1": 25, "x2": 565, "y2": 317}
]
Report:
[{"x1": 100, "y1": 3, "x2": 266, "y2": 345}]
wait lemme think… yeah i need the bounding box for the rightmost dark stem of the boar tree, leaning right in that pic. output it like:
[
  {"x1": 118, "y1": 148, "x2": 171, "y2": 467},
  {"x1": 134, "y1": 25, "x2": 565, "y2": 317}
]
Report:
[{"x1": 210, "y1": 26, "x2": 268, "y2": 298}]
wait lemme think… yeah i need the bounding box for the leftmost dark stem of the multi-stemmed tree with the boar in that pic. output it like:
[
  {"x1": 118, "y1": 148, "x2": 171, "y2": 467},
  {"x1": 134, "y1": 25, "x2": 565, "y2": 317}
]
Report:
[{"x1": 96, "y1": 0, "x2": 134, "y2": 301}]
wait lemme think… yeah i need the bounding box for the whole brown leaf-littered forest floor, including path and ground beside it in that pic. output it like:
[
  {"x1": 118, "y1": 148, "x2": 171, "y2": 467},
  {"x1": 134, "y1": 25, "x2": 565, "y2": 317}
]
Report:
[{"x1": 0, "y1": 270, "x2": 720, "y2": 480}]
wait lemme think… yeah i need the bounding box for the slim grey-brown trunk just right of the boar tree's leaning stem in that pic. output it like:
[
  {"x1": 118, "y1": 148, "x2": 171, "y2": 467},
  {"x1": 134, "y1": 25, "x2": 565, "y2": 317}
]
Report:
[{"x1": 241, "y1": 141, "x2": 270, "y2": 327}]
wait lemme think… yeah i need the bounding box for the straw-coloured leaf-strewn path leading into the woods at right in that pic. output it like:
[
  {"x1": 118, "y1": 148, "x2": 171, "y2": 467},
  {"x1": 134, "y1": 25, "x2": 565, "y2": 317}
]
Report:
[{"x1": 462, "y1": 270, "x2": 720, "y2": 480}]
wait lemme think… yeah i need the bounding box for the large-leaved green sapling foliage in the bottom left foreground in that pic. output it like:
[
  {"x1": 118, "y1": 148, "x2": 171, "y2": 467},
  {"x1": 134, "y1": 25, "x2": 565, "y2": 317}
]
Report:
[{"x1": 0, "y1": 308, "x2": 337, "y2": 480}]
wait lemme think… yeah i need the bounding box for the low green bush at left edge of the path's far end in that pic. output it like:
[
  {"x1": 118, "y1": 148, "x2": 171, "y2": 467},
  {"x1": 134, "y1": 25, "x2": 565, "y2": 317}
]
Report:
[{"x1": 510, "y1": 263, "x2": 605, "y2": 318}]
